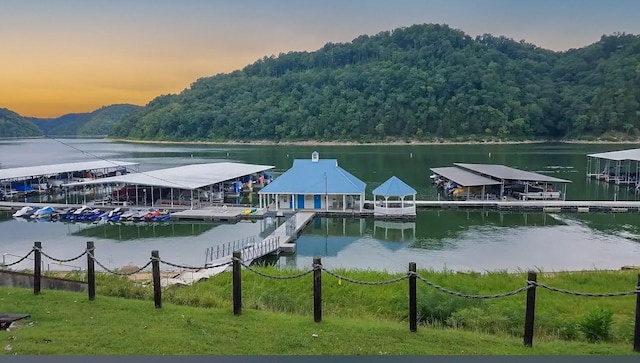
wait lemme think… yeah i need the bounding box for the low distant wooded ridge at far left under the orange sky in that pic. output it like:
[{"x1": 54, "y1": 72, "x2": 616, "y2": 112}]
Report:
[{"x1": 0, "y1": 104, "x2": 141, "y2": 138}]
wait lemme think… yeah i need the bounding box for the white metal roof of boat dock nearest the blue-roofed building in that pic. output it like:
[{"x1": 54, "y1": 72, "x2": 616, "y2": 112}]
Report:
[{"x1": 64, "y1": 162, "x2": 274, "y2": 190}]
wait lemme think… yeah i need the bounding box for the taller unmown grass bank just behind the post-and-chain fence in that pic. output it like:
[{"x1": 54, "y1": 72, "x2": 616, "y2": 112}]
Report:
[{"x1": 87, "y1": 267, "x2": 637, "y2": 344}]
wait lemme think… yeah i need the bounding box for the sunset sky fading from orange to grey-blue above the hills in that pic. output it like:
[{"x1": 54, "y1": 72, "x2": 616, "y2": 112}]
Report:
[{"x1": 0, "y1": 0, "x2": 640, "y2": 117}]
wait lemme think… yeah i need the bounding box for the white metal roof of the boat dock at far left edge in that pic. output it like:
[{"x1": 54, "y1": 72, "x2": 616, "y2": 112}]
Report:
[{"x1": 0, "y1": 160, "x2": 138, "y2": 180}]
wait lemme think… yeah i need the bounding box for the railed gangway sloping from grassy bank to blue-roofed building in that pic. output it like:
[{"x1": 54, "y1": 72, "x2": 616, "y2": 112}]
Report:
[{"x1": 161, "y1": 212, "x2": 315, "y2": 286}]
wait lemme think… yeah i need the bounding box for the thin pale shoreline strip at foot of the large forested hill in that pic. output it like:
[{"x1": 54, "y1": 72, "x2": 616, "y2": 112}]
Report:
[{"x1": 105, "y1": 138, "x2": 640, "y2": 146}]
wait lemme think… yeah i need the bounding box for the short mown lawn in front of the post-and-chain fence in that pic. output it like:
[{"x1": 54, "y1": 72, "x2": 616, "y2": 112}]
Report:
[{"x1": 0, "y1": 288, "x2": 633, "y2": 355}]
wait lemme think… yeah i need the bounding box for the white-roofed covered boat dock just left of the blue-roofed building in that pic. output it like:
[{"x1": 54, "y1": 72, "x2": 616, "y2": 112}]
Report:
[{"x1": 64, "y1": 162, "x2": 274, "y2": 209}]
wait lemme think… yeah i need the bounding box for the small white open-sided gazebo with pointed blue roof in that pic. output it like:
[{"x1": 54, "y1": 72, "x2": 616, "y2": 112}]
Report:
[{"x1": 373, "y1": 176, "x2": 417, "y2": 217}]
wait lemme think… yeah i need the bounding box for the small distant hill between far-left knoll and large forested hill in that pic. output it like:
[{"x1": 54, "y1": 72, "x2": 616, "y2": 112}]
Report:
[{"x1": 32, "y1": 104, "x2": 140, "y2": 136}]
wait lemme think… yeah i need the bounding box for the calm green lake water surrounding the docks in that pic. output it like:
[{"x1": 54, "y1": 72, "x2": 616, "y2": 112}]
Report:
[{"x1": 0, "y1": 139, "x2": 640, "y2": 271}]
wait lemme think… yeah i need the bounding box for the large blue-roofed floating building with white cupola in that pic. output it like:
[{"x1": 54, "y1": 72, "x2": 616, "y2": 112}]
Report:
[{"x1": 258, "y1": 151, "x2": 367, "y2": 212}]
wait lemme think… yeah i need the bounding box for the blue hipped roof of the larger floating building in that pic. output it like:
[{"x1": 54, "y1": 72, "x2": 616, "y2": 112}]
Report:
[{"x1": 258, "y1": 159, "x2": 367, "y2": 194}]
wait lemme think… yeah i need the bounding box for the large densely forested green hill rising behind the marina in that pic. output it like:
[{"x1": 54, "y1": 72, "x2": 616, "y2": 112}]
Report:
[{"x1": 111, "y1": 25, "x2": 640, "y2": 142}]
